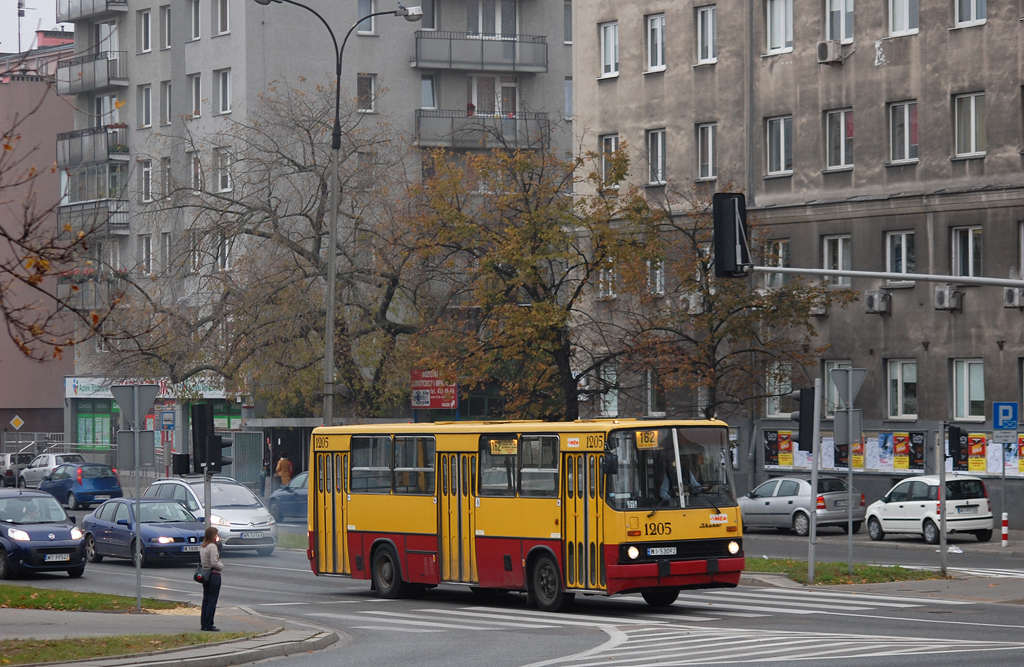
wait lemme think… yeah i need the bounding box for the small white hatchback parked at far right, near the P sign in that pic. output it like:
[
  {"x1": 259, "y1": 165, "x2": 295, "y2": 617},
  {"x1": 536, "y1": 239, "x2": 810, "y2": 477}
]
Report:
[{"x1": 867, "y1": 474, "x2": 994, "y2": 544}]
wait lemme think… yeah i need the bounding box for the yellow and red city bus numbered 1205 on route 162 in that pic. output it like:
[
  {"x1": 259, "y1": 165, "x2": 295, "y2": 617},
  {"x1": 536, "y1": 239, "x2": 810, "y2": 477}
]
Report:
[{"x1": 306, "y1": 419, "x2": 744, "y2": 611}]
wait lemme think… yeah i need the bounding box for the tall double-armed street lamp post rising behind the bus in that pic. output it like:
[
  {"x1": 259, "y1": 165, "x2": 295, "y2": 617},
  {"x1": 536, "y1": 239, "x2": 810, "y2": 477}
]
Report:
[{"x1": 256, "y1": 0, "x2": 423, "y2": 426}]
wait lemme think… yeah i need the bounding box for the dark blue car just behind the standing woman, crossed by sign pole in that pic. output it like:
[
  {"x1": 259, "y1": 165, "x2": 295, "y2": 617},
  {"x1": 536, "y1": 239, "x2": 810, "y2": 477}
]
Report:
[{"x1": 82, "y1": 498, "x2": 206, "y2": 566}]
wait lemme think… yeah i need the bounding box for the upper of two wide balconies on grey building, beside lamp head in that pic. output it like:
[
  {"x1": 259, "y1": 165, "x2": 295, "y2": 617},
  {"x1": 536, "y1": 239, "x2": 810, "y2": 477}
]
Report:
[{"x1": 412, "y1": 30, "x2": 548, "y2": 72}]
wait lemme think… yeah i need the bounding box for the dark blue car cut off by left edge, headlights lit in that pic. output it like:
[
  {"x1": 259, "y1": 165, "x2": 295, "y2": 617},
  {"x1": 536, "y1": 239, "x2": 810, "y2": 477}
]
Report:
[{"x1": 0, "y1": 489, "x2": 85, "y2": 579}]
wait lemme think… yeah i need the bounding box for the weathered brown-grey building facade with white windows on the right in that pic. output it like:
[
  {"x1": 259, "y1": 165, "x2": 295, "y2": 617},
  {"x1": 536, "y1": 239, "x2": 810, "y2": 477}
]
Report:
[{"x1": 573, "y1": 0, "x2": 1024, "y2": 510}]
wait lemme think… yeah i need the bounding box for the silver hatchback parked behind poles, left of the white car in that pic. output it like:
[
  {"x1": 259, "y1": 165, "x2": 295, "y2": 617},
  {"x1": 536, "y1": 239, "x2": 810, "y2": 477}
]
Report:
[{"x1": 739, "y1": 476, "x2": 865, "y2": 537}]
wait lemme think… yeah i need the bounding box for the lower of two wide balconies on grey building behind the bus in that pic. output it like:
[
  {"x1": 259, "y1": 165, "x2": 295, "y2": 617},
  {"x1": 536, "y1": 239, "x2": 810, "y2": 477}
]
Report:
[{"x1": 416, "y1": 109, "x2": 549, "y2": 149}]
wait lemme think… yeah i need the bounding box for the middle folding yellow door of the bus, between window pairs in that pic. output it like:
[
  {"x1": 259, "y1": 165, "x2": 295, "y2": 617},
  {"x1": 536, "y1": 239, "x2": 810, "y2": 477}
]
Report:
[{"x1": 438, "y1": 453, "x2": 476, "y2": 583}]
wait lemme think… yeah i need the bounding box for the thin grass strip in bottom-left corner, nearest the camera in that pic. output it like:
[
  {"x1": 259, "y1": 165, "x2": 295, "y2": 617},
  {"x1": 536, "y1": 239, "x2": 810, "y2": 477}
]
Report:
[{"x1": 0, "y1": 632, "x2": 249, "y2": 665}]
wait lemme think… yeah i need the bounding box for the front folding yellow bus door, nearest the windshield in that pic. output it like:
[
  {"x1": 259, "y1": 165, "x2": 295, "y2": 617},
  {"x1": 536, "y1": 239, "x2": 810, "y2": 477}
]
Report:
[{"x1": 562, "y1": 452, "x2": 605, "y2": 589}]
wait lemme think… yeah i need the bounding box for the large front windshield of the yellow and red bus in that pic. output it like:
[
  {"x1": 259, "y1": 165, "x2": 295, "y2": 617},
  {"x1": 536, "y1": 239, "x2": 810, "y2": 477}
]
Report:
[{"x1": 606, "y1": 425, "x2": 736, "y2": 510}]
